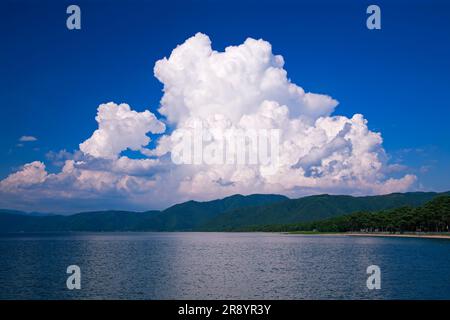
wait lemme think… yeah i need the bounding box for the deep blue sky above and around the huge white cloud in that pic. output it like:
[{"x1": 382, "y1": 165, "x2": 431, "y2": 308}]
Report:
[{"x1": 0, "y1": 0, "x2": 450, "y2": 212}]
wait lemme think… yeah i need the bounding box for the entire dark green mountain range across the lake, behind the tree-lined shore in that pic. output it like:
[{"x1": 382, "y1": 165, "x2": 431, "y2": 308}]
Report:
[{"x1": 0, "y1": 192, "x2": 450, "y2": 233}]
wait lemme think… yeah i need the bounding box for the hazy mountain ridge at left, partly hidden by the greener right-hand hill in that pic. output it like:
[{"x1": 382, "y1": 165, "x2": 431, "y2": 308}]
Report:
[{"x1": 0, "y1": 194, "x2": 288, "y2": 232}]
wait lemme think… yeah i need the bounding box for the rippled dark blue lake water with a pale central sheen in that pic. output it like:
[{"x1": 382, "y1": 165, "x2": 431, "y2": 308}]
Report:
[{"x1": 0, "y1": 233, "x2": 450, "y2": 299}]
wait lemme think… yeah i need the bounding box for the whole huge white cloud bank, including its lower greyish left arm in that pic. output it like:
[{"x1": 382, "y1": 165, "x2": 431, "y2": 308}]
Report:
[{"x1": 0, "y1": 33, "x2": 416, "y2": 208}]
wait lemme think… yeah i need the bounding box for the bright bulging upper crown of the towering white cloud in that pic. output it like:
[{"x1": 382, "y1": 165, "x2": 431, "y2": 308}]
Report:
[{"x1": 154, "y1": 33, "x2": 337, "y2": 123}]
